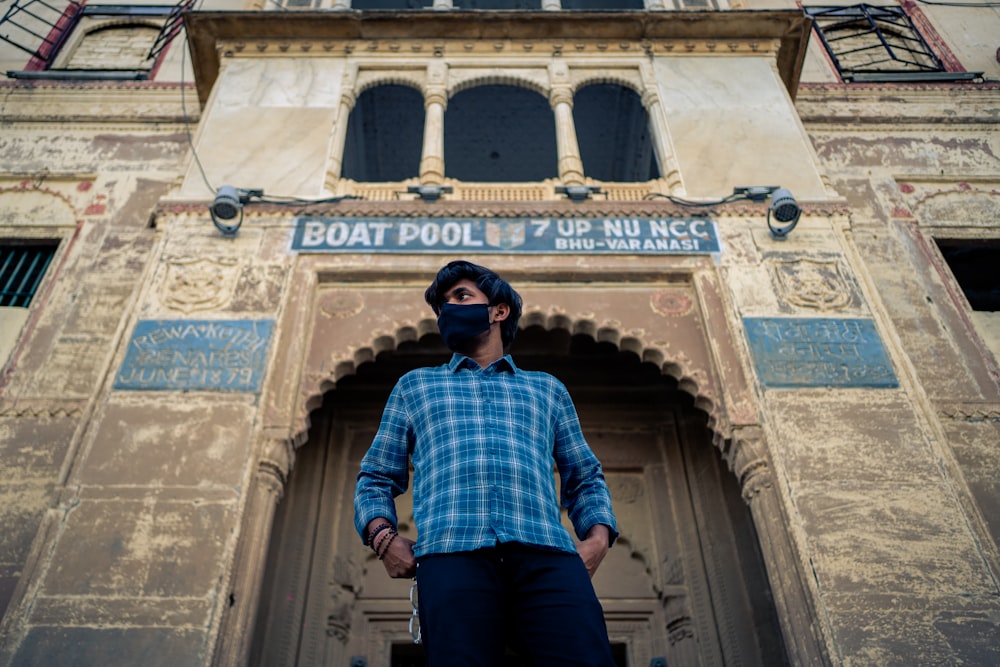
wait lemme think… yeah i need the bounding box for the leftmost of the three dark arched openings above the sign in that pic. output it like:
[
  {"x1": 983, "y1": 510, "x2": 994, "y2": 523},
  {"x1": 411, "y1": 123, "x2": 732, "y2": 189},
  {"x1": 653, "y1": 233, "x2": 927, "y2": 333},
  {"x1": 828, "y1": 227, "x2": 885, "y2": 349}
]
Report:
[{"x1": 341, "y1": 85, "x2": 424, "y2": 183}]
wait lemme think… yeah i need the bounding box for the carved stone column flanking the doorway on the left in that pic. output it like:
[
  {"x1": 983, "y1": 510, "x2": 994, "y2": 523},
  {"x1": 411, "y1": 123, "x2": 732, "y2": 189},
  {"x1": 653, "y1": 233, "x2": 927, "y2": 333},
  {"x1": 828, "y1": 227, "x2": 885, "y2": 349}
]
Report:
[{"x1": 212, "y1": 440, "x2": 294, "y2": 667}]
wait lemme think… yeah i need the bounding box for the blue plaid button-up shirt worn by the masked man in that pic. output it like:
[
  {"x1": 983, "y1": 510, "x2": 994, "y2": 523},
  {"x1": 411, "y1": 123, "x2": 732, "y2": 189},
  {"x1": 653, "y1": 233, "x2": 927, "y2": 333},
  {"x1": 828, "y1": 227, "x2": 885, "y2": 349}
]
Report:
[{"x1": 354, "y1": 354, "x2": 617, "y2": 557}]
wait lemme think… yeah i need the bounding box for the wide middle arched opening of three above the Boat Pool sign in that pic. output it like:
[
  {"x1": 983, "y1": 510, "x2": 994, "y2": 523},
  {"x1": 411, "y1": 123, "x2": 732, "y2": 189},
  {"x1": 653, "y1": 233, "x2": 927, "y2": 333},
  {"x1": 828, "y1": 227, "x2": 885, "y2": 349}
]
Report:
[{"x1": 444, "y1": 85, "x2": 559, "y2": 183}]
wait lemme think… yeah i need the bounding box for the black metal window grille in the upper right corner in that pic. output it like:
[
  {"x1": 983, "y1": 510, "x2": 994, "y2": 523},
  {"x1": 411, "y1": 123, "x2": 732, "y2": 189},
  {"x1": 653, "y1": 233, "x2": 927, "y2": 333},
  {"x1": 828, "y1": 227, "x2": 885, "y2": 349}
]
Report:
[{"x1": 805, "y1": 4, "x2": 982, "y2": 82}]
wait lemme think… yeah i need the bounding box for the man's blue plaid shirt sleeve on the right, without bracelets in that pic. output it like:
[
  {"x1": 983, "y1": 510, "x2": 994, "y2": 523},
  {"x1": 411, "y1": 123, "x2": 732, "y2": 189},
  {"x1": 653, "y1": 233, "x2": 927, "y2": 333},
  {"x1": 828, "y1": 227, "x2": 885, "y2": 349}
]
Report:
[{"x1": 554, "y1": 386, "x2": 618, "y2": 544}]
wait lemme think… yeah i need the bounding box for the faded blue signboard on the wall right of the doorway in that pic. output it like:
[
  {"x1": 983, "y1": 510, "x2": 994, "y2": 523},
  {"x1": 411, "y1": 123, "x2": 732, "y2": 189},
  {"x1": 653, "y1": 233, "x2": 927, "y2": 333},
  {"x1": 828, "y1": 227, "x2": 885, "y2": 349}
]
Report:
[{"x1": 743, "y1": 317, "x2": 899, "y2": 387}]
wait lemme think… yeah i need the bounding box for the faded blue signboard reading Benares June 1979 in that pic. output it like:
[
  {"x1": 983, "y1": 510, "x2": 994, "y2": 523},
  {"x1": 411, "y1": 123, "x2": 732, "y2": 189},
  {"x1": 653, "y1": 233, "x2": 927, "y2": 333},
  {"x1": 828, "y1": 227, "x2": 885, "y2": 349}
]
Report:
[{"x1": 114, "y1": 320, "x2": 274, "y2": 392}]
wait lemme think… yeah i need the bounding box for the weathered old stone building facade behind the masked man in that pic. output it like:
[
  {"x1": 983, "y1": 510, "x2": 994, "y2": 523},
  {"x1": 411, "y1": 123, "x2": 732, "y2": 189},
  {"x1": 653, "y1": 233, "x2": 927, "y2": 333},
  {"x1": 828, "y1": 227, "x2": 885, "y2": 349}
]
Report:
[{"x1": 0, "y1": 0, "x2": 1000, "y2": 667}]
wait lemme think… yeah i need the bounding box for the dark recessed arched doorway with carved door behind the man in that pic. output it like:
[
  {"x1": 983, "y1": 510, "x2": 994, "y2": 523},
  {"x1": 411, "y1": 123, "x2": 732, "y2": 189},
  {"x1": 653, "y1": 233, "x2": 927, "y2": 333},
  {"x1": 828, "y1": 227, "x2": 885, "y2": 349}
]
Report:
[{"x1": 251, "y1": 326, "x2": 787, "y2": 667}]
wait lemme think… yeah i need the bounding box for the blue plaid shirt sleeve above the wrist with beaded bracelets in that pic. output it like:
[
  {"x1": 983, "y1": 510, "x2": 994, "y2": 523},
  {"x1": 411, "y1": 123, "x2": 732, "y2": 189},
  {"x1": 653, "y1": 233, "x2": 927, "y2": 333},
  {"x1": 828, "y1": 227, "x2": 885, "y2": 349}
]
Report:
[{"x1": 354, "y1": 382, "x2": 413, "y2": 541}]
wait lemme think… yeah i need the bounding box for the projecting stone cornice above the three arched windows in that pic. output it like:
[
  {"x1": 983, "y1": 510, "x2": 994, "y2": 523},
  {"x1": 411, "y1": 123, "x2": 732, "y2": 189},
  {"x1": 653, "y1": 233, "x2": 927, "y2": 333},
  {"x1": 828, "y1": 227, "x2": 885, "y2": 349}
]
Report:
[{"x1": 184, "y1": 10, "x2": 812, "y2": 104}]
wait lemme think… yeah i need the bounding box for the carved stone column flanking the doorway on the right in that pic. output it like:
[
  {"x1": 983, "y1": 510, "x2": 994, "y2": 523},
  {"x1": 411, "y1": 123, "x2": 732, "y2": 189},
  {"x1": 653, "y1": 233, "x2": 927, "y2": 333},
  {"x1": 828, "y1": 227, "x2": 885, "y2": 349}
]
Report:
[{"x1": 727, "y1": 427, "x2": 830, "y2": 666}]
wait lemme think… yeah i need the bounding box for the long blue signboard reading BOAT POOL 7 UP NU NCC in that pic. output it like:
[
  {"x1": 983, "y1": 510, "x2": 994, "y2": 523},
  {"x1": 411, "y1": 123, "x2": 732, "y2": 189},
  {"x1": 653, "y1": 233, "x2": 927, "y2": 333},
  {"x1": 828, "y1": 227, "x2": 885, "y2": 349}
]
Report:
[{"x1": 292, "y1": 217, "x2": 719, "y2": 255}]
